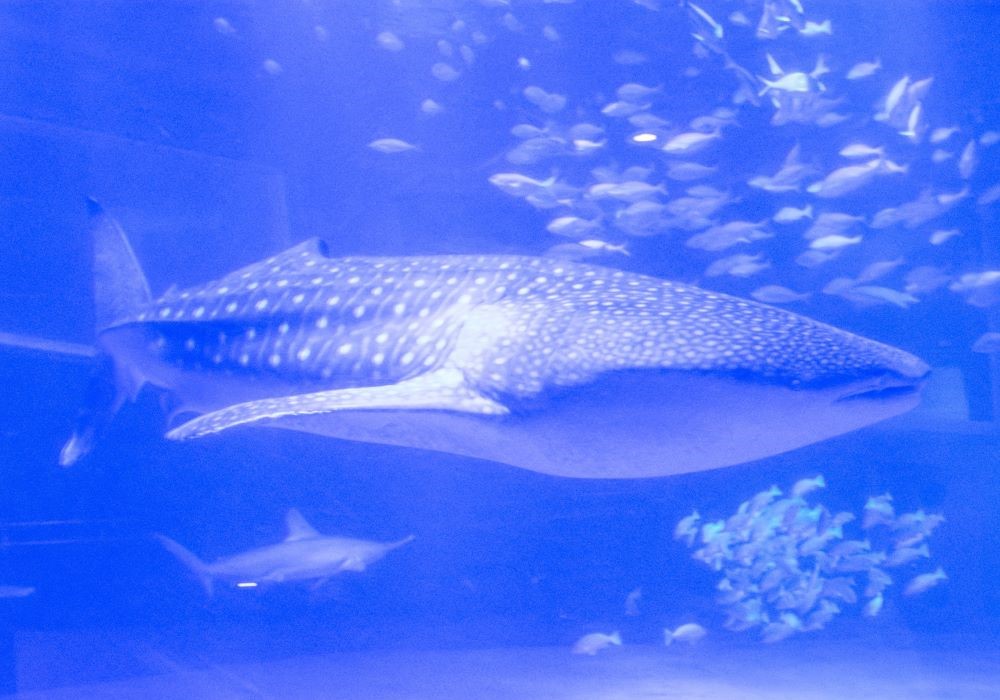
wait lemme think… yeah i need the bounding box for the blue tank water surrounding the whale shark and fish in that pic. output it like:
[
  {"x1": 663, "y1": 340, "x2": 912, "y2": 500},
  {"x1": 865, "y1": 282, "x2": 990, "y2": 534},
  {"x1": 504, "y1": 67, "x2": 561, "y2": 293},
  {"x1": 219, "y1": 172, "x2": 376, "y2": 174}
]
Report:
[{"x1": 0, "y1": 0, "x2": 1000, "y2": 697}]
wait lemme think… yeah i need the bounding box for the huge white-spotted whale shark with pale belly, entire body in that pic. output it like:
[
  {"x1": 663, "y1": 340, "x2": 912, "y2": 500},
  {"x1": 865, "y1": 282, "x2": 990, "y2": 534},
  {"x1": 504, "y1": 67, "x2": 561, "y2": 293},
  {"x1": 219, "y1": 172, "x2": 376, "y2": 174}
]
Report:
[{"x1": 60, "y1": 203, "x2": 929, "y2": 478}]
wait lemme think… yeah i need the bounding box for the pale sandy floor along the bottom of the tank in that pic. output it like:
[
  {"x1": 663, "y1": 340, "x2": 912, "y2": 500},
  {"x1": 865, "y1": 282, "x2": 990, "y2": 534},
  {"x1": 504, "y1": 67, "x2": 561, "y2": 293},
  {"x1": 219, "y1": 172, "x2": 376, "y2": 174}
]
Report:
[{"x1": 5, "y1": 636, "x2": 1000, "y2": 700}]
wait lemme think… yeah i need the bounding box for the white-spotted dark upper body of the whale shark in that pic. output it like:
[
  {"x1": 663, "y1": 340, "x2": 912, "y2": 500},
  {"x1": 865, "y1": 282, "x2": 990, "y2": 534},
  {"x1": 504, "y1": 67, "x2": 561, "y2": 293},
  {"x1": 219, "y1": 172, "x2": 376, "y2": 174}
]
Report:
[{"x1": 122, "y1": 243, "x2": 922, "y2": 397}]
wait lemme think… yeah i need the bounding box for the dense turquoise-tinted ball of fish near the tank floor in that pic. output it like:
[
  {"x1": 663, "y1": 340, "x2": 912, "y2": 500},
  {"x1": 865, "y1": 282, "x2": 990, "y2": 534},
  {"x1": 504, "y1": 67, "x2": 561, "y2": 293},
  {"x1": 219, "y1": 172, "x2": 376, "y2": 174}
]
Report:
[{"x1": 674, "y1": 475, "x2": 948, "y2": 643}]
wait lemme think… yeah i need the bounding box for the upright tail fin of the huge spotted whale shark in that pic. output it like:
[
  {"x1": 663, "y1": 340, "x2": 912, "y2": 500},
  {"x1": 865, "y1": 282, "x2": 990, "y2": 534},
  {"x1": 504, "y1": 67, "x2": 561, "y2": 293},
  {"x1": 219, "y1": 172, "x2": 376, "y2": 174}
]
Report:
[{"x1": 59, "y1": 199, "x2": 151, "y2": 467}]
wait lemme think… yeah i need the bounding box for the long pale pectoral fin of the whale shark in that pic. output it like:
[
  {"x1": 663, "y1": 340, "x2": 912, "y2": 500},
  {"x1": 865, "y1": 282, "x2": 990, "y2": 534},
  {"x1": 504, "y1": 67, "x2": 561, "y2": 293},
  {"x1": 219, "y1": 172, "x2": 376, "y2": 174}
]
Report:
[{"x1": 167, "y1": 369, "x2": 509, "y2": 440}]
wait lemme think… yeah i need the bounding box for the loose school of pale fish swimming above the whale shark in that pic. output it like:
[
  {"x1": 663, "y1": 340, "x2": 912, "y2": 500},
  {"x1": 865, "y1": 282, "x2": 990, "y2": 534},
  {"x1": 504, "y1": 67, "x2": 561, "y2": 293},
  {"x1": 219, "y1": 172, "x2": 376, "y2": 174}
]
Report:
[{"x1": 227, "y1": 0, "x2": 1000, "y2": 348}]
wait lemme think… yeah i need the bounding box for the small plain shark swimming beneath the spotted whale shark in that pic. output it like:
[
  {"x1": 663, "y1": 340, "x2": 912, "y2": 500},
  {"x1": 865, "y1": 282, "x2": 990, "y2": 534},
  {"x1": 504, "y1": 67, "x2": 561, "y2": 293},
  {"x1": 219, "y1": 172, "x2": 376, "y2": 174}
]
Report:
[{"x1": 154, "y1": 508, "x2": 414, "y2": 596}]
